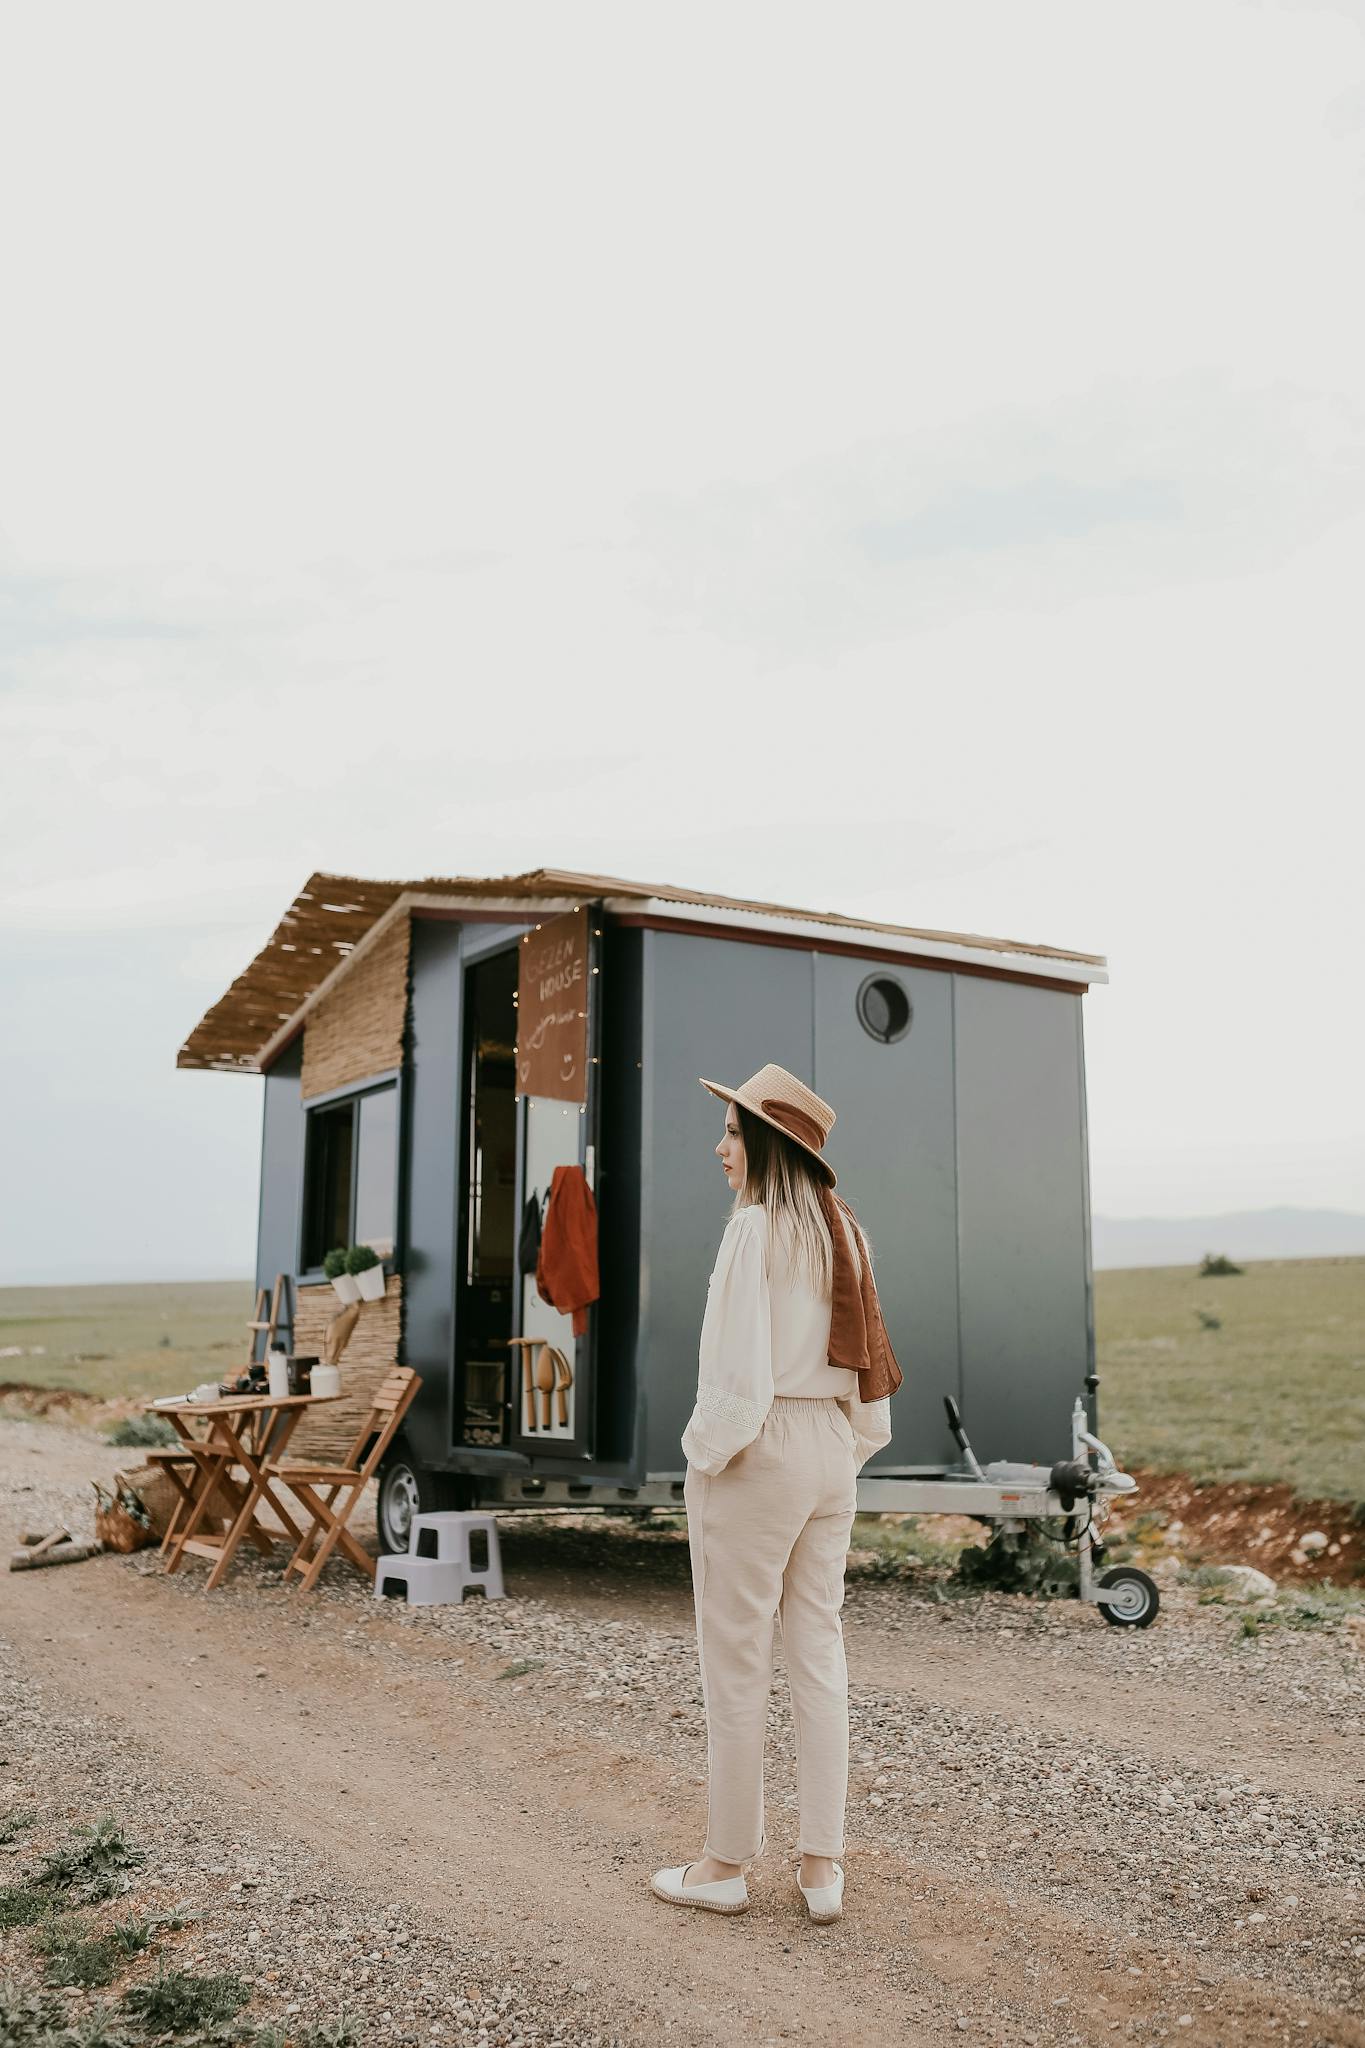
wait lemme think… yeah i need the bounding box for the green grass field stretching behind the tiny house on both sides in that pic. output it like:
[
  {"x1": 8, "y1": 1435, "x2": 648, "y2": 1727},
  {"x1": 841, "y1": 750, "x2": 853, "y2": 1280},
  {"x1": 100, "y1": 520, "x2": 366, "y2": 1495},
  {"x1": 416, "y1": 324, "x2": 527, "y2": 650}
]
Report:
[{"x1": 0, "y1": 1260, "x2": 1365, "y2": 1501}]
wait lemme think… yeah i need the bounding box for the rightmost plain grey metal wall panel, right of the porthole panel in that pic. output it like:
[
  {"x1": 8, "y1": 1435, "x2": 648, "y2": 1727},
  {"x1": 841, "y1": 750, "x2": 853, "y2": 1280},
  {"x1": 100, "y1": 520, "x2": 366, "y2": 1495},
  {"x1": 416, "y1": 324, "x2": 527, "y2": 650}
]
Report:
[{"x1": 954, "y1": 975, "x2": 1089, "y2": 1462}]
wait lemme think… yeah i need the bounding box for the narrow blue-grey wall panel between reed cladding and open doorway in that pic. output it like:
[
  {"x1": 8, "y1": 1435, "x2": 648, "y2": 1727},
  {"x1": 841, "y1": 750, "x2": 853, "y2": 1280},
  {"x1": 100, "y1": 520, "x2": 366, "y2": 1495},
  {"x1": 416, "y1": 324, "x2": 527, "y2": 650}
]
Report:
[{"x1": 401, "y1": 918, "x2": 465, "y2": 1464}]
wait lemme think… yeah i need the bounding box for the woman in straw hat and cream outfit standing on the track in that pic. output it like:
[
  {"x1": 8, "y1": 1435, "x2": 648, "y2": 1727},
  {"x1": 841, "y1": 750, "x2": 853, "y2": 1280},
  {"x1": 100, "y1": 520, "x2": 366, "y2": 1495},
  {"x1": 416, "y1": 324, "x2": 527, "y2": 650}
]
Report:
[{"x1": 653, "y1": 1065, "x2": 900, "y2": 1921}]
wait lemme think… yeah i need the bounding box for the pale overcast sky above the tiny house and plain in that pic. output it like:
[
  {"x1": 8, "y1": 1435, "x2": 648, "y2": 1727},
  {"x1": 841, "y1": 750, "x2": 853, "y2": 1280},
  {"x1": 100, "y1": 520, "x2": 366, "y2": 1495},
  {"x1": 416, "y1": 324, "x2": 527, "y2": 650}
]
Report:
[{"x1": 0, "y1": 0, "x2": 1365, "y2": 1282}]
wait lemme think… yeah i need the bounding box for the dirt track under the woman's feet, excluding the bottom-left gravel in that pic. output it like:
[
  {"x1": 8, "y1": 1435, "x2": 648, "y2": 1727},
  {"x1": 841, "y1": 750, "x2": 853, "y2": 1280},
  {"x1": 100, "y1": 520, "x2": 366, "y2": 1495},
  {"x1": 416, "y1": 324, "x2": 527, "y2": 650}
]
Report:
[{"x1": 2, "y1": 1520, "x2": 1365, "y2": 2048}]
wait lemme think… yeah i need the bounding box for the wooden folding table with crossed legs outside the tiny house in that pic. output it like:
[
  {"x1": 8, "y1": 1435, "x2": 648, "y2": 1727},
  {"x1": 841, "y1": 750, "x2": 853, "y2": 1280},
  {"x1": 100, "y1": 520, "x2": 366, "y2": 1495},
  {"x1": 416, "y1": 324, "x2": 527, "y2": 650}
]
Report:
[{"x1": 145, "y1": 1395, "x2": 342, "y2": 1593}]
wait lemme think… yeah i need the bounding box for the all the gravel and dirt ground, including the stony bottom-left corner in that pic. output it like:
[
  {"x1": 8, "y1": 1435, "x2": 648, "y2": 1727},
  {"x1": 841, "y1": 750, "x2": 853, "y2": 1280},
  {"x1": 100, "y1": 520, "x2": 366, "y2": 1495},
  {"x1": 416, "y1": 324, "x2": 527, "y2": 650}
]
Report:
[{"x1": 0, "y1": 1423, "x2": 1365, "y2": 2048}]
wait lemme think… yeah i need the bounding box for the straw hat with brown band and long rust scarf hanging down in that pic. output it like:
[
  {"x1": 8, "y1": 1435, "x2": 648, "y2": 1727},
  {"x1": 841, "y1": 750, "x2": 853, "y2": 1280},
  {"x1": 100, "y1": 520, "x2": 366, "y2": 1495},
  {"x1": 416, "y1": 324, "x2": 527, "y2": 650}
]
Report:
[{"x1": 698, "y1": 1065, "x2": 905, "y2": 1401}]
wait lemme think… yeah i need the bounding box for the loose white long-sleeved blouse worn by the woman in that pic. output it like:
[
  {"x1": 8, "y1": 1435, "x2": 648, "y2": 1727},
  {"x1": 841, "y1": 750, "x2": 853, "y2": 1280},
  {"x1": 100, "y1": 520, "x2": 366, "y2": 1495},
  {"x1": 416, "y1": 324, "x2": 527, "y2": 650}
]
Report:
[{"x1": 681, "y1": 1202, "x2": 890, "y2": 1475}]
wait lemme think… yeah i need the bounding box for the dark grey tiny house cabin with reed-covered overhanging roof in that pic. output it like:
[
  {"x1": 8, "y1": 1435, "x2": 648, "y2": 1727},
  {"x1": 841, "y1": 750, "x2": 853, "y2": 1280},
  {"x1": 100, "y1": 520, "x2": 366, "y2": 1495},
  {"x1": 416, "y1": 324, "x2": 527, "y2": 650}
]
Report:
[{"x1": 178, "y1": 868, "x2": 1107, "y2": 1550}]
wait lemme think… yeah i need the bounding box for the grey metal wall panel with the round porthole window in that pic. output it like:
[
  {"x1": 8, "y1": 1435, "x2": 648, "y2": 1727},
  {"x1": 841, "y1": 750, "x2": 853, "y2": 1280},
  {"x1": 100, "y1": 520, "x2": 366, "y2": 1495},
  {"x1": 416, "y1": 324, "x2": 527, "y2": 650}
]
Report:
[{"x1": 810, "y1": 952, "x2": 960, "y2": 1473}]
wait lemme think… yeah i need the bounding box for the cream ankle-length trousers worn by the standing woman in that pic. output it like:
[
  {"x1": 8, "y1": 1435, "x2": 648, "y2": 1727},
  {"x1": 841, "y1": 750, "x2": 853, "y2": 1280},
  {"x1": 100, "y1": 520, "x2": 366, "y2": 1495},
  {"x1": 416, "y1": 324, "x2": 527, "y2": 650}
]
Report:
[{"x1": 684, "y1": 1395, "x2": 857, "y2": 1864}]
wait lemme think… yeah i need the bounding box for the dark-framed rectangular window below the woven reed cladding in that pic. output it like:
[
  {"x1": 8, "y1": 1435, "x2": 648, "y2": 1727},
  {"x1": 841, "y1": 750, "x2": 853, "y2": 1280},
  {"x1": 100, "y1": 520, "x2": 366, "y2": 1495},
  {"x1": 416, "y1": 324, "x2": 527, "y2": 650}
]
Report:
[{"x1": 303, "y1": 1081, "x2": 399, "y2": 1272}]
